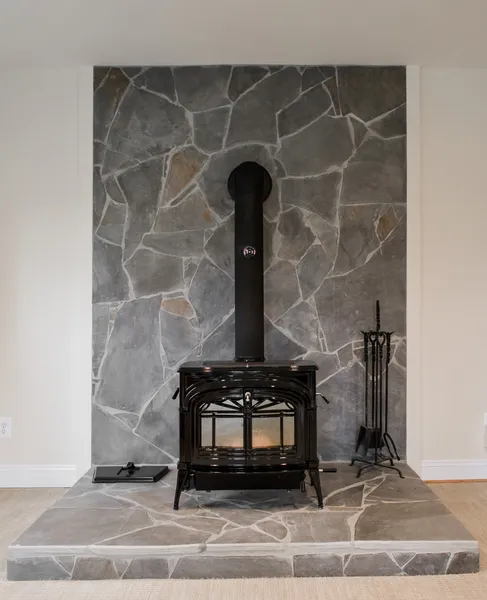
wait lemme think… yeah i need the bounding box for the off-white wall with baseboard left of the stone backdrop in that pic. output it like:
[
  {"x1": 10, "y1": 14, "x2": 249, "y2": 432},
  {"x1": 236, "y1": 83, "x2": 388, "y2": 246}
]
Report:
[{"x1": 0, "y1": 68, "x2": 92, "y2": 486}]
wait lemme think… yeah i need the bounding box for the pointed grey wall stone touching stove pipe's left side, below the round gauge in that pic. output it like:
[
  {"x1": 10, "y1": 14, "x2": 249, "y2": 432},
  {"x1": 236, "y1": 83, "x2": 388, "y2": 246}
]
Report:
[{"x1": 188, "y1": 258, "x2": 234, "y2": 335}]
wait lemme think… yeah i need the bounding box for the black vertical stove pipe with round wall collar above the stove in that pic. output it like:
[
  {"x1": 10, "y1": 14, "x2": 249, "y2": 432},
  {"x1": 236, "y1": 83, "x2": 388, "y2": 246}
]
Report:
[{"x1": 228, "y1": 162, "x2": 272, "y2": 362}]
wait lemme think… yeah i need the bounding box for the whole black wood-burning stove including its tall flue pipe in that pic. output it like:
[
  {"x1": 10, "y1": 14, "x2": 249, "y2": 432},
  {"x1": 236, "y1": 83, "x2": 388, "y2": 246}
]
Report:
[{"x1": 174, "y1": 162, "x2": 332, "y2": 510}]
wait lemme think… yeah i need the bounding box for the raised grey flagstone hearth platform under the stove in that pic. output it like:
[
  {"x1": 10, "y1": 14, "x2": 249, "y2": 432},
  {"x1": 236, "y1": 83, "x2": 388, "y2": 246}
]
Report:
[{"x1": 7, "y1": 463, "x2": 479, "y2": 580}]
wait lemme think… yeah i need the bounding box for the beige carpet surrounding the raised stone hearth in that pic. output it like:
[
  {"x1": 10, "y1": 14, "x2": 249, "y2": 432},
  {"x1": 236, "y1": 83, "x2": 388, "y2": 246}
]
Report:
[{"x1": 0, "y1": 483, "x2": 487, "y2": 600}]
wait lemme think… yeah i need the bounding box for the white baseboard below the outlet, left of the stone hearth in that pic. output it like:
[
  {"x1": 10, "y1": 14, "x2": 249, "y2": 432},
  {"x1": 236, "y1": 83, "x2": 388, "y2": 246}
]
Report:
[{"x1": 0, "y1": 465, "x2": 78, "y2": 488}]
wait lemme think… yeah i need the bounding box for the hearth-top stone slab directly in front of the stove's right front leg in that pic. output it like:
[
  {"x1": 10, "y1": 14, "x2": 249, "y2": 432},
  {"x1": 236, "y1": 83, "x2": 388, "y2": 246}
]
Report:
[{"x1": 282, "y1": 510, "x2": 353, "y2": 543}]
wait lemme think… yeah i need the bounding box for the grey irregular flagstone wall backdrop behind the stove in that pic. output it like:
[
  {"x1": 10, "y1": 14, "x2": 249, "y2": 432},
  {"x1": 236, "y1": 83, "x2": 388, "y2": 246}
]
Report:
[{"x1": 93, "y1": 66, "x2": 406, "y2": 464}]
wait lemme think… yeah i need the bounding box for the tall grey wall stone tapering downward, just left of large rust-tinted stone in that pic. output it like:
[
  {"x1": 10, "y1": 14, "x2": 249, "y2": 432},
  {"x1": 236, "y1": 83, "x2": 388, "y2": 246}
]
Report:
[{"x1": 118, "y1": 160, "x2": 163, "y2": 258}]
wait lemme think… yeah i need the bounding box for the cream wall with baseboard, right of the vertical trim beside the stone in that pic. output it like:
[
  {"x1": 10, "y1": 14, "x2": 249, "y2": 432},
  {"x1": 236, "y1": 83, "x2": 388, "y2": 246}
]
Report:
[{"x1": 422, "y1": 69, "x2": 487, "y2": 479}]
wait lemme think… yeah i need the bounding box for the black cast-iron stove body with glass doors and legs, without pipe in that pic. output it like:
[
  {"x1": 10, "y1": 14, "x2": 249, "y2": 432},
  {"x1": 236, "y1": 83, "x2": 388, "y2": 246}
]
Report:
[{"x1": 174, "y1": 361, "x2": 323, "y2": 509}]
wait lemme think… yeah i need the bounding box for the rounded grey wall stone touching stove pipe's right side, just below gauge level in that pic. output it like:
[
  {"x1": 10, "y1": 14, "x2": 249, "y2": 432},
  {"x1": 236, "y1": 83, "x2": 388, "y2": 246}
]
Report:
[{"x1": 264, "y1": 260, "x2": 299, "y2": 321}]
